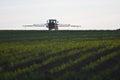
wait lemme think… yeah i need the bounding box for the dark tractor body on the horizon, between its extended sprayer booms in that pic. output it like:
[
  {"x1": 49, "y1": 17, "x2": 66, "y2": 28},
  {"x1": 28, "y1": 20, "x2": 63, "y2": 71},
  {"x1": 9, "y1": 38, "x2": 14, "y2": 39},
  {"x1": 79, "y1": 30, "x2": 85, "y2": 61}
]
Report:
[{"x1": 47, "y1": 19, "x2": 58, "y2": 30}]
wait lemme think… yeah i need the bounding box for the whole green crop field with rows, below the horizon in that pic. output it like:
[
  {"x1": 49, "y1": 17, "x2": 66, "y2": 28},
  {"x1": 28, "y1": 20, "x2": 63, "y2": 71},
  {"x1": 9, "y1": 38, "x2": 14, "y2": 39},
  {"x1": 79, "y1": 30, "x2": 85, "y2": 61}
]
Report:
[{"x1": 0, "y1": 30, "x2": 120, "y2": 80}]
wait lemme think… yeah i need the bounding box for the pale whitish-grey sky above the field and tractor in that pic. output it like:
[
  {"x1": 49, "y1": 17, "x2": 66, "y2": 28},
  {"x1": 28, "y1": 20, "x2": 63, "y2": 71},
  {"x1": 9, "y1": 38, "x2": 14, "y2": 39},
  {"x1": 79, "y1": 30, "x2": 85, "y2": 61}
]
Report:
[{"x1": 0, "y1": 0, "x2": 120, "y2": 30}]
